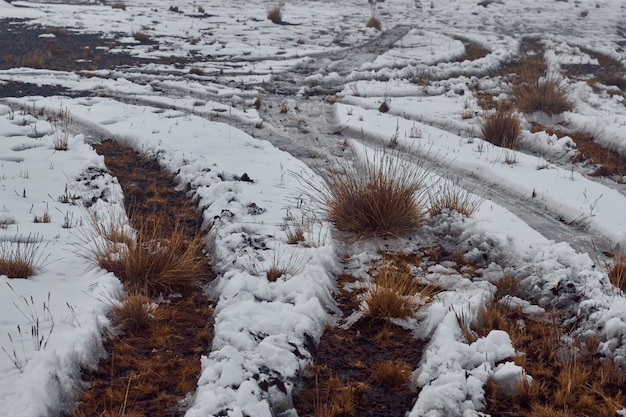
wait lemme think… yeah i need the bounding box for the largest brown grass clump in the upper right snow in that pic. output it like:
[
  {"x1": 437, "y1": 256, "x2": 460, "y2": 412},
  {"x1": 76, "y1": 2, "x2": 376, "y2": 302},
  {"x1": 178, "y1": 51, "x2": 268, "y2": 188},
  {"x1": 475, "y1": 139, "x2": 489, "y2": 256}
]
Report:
[{"x1": 513, "y1": 59, "x2": 574, "y2": 116}]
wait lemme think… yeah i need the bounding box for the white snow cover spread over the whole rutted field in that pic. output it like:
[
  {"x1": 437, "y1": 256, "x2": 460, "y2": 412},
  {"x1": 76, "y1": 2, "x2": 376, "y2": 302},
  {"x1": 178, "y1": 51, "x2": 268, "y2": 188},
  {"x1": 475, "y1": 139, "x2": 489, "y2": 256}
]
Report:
[{"x1": 0, "y1": 0, "x2": 626, "y2": 416}]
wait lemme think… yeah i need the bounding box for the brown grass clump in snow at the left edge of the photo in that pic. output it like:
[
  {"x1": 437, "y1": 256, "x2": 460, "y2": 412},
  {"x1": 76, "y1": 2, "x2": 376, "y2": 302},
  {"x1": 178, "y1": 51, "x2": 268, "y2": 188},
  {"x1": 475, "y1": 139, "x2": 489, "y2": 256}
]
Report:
[{"x1": 0, "y1": 235, "x2": 41, "y2": 278}]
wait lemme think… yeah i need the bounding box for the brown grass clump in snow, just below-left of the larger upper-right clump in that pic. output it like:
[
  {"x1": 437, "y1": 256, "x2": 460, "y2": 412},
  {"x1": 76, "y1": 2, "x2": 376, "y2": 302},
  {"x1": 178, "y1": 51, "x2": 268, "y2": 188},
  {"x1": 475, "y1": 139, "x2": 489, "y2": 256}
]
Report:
[{"x1": 480, "y1": 104, "x2": 520, "y2": 149}]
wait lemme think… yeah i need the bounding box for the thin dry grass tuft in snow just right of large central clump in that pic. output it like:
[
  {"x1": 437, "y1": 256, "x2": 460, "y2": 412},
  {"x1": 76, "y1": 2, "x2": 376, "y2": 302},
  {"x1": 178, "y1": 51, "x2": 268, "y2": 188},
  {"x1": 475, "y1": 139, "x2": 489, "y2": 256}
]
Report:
[{"x1": 428, "y1": 180, "x2": 483, "y2": 218}]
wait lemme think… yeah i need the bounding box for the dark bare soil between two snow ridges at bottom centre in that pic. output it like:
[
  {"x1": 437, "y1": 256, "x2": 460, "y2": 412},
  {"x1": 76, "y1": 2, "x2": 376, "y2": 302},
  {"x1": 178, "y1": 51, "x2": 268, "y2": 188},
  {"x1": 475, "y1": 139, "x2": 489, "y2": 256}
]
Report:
[{"x1": 294, "y1": 275, "x2": 424, "y2": 417}]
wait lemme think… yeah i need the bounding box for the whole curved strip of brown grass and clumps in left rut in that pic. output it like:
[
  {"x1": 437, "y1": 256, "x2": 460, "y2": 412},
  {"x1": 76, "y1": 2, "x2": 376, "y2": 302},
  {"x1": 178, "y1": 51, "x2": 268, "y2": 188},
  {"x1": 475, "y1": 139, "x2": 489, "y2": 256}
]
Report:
[{"x1": 73, "y1": 142, "x2": 213, "y2": 417}]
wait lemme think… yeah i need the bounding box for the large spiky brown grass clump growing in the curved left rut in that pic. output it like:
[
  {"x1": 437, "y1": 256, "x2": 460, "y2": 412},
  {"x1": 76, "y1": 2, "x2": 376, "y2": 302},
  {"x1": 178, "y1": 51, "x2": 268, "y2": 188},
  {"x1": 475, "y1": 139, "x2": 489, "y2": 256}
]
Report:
[{"x1": 89, "y1": 214, "x2": 207, "y2": 296}]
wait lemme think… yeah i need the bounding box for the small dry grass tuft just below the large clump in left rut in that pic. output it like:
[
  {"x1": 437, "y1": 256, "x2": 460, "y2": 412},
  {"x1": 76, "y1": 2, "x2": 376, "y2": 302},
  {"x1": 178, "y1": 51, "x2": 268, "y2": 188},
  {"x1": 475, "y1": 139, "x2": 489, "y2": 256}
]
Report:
[{"x1": 112, "y1": 295, "x2": 164, "y2": 335}]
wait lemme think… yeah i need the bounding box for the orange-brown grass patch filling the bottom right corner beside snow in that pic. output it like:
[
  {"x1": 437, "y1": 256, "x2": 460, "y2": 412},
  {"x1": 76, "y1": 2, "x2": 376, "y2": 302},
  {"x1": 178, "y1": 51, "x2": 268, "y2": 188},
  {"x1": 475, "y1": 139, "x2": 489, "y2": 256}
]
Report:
[{"x1": 468, "y1": 278, "x2": 626, "y2": 417}]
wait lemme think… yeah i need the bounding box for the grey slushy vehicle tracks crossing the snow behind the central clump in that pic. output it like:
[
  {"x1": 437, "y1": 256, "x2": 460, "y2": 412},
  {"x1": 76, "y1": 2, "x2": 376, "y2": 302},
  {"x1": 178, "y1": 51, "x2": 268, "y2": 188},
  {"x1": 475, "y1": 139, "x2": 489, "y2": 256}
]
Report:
[{"x1": 50, "y1": 25, "x2": 614, "y2": 256}]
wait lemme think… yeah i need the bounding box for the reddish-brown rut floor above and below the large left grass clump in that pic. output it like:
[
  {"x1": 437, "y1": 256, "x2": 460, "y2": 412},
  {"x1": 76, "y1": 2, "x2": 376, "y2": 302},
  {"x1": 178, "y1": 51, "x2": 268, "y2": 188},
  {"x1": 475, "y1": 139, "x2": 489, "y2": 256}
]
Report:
[{"x1": 73, "y1": 141, "x2": 213, "y2": 416}]
